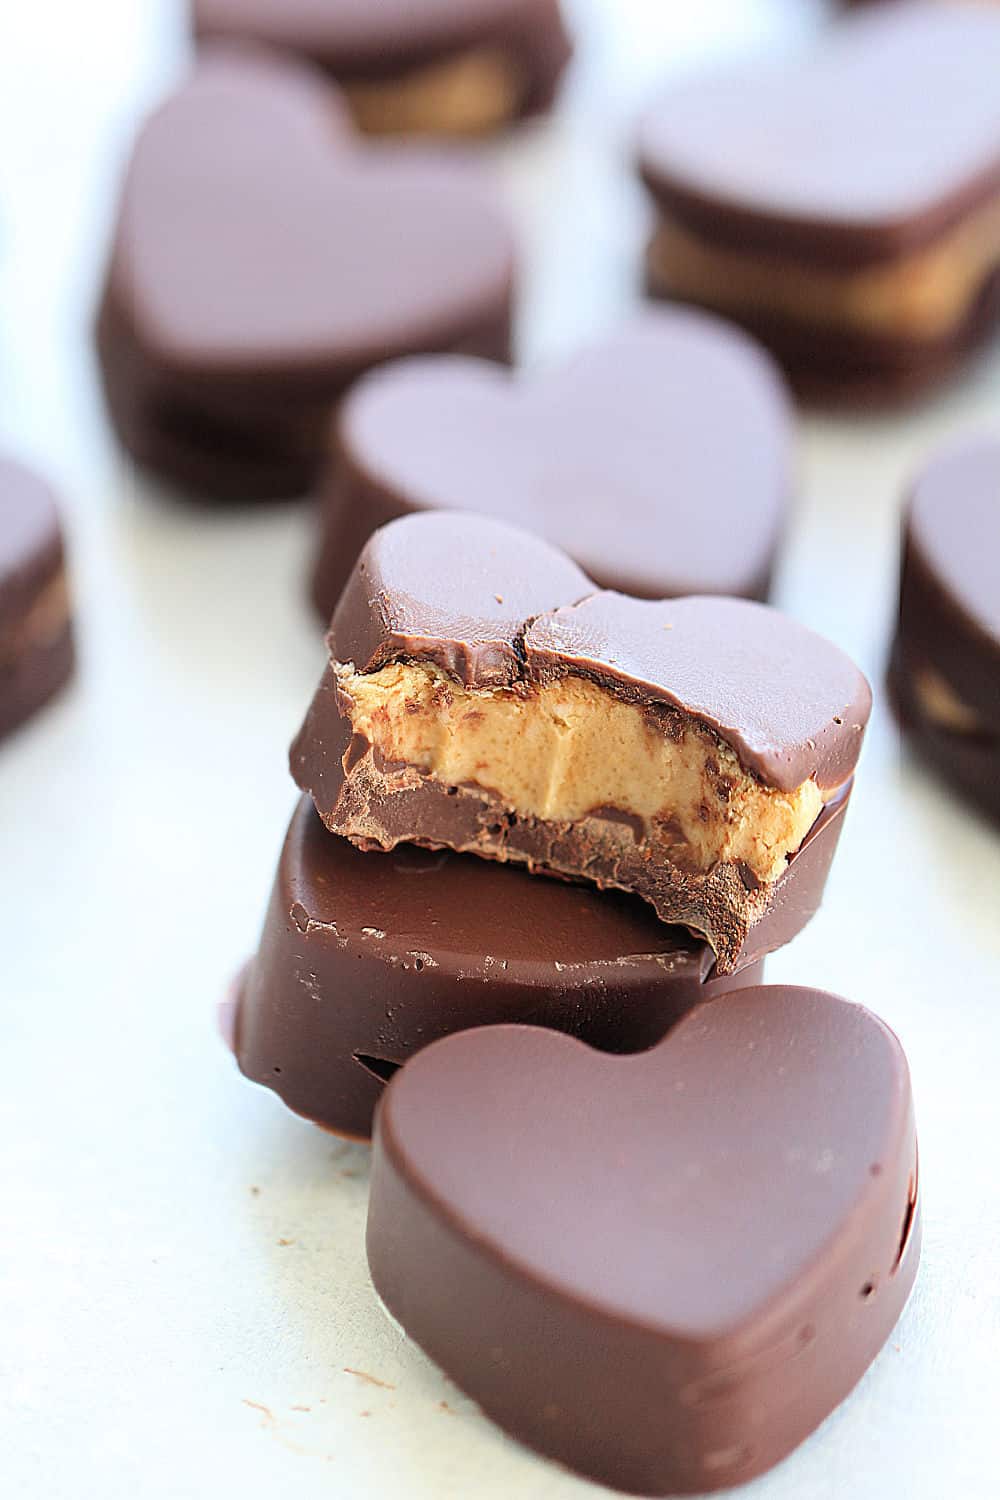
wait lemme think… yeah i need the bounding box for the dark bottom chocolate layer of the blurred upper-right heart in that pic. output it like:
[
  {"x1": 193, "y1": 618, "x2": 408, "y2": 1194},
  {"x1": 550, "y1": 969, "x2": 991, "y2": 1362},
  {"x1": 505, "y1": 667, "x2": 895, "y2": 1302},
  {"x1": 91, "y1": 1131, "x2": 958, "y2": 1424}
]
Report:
[{"x1": 646, "y1": 255, "x2": 1000, "y2": 407}]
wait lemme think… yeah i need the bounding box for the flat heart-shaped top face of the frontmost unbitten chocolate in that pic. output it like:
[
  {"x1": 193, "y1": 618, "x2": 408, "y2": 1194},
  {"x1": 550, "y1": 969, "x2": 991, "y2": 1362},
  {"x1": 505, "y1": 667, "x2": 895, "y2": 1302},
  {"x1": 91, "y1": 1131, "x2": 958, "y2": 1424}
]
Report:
[{"x1": 378, "y1": 986, "x2": 910, "y2": 1340}]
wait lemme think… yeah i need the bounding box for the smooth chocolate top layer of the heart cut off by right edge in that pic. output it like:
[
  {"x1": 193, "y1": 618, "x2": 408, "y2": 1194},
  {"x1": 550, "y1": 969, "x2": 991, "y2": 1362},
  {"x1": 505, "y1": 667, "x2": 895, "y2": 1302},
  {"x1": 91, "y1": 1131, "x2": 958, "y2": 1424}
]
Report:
[{"x1": 900, "y1": 438, "x2": 1000, "y2": 728}]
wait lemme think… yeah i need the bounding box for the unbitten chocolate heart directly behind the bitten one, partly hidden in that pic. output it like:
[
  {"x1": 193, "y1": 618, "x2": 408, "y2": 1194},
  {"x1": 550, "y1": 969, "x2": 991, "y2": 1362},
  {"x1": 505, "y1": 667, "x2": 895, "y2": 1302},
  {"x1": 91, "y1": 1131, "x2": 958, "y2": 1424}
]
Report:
[{"x1": 313, "y1": 309, "x2": 792, "y2": 620}]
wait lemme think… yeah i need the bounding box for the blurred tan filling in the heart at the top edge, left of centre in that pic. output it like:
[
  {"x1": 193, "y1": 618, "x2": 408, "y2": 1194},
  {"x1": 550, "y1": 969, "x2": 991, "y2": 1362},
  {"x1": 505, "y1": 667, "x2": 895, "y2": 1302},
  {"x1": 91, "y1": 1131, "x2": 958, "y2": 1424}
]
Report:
[{"x1": 345, "y1": 47, "x2": 525, "y2": 135}]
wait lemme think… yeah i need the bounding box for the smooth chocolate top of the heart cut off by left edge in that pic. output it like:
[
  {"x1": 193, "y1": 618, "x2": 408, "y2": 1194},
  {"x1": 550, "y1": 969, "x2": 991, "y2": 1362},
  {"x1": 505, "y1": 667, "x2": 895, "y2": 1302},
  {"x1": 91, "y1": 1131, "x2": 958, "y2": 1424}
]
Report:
[{"x1": 0, "y1": 458, "x2": 63, "y2": 630}]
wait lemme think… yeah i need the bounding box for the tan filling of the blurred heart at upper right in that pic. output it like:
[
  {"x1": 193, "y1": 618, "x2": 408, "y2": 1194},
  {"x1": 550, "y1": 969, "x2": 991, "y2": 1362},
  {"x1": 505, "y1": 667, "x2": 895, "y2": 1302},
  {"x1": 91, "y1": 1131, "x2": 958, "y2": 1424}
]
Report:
[{"x1": 648, "y1": 195, "x2": 1000, "y2": 339}]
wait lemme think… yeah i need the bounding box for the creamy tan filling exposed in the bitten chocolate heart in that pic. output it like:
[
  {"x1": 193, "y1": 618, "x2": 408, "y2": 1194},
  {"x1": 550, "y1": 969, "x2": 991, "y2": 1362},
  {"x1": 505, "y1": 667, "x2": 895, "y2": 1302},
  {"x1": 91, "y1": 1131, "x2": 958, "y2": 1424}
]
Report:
[{"x1": 337, "y1": 663, "x2": 823, "y2": 881}]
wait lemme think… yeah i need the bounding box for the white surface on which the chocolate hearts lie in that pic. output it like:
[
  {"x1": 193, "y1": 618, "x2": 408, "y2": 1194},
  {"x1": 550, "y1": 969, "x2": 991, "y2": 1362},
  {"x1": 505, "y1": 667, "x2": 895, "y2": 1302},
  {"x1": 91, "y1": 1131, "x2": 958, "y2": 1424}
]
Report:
[{"x1": 0, "y1": 0, "x2": 1000, "y2": 1500}]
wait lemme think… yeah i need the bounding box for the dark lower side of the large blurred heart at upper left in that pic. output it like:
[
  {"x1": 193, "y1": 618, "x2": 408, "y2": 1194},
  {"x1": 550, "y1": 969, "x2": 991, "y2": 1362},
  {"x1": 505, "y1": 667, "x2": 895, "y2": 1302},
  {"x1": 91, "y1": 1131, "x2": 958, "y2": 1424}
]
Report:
[{"x1": 96, "y1": 291, "x2": 510, "y2": 503}]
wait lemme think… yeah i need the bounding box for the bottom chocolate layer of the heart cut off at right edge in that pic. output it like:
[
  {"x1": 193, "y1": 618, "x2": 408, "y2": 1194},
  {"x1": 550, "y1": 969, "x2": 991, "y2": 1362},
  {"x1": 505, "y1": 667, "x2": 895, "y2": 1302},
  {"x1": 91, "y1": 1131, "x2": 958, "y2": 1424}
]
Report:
[{"x1": 888, "y1": 638, "x2": 1000, "y2": 822}]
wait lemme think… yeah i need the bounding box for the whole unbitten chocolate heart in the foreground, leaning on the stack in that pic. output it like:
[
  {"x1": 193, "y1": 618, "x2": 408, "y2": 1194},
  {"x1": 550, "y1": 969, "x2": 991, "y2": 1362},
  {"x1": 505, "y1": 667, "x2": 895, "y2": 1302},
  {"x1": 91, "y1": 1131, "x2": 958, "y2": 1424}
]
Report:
[{"x1": 367, "y1": 987, "x2": 921, "y2": 1494}]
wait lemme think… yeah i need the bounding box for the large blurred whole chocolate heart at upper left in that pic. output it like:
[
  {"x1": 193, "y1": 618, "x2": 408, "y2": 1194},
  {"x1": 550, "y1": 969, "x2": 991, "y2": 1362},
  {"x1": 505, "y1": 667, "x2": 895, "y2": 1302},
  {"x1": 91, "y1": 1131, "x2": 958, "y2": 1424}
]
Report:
[{"x1": 97, "y1": 51, "x2": 513, "y2": 498}]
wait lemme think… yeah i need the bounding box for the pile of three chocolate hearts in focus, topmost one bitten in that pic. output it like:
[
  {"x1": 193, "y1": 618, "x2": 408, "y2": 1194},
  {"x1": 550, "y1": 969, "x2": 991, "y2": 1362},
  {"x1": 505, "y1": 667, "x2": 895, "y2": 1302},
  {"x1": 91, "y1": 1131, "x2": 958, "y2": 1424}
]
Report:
[{"x1": 231, "y1": 512, "x2": 919, "y2": 1493}]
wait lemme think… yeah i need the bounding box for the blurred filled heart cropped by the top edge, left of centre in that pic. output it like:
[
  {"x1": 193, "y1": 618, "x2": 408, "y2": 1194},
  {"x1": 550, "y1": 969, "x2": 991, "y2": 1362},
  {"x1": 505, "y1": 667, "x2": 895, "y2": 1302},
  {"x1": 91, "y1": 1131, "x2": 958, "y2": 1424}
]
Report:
[{"x1": 192, "y1": 0, "x2": 570, "y2": 135}]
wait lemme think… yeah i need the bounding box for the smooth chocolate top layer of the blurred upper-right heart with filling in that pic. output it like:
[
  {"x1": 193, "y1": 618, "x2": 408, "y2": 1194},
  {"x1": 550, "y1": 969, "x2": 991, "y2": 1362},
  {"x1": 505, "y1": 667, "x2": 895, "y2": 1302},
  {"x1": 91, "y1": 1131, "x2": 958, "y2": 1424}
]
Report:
[{"x1": 639, "y1": 3, "x2": 1000, "y2": 267}]
